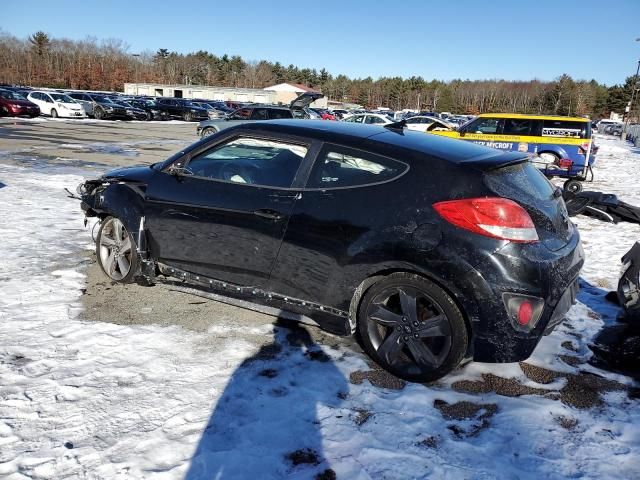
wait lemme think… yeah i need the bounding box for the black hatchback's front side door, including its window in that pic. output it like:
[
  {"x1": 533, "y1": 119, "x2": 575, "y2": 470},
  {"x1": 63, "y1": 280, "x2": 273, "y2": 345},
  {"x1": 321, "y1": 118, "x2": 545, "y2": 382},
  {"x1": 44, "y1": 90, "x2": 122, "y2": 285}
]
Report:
[{"x1": 145, "y1": 131, "x2": 310, "y2": 287}]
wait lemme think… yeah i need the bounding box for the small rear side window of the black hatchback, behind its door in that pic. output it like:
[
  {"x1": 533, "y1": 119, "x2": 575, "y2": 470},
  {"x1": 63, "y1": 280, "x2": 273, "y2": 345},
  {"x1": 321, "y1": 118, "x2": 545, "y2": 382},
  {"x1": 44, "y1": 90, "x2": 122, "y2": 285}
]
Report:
[{"x1": 307, "y1": 145, "x2": 409, "y2": 189}]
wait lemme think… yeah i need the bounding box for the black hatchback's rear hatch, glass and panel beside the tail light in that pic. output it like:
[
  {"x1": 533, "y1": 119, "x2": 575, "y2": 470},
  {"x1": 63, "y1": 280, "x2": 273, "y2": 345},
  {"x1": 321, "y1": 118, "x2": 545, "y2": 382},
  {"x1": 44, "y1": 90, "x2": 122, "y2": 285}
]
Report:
[{"x1": 484, "y1": 161, "x2": 573, "y2": 251}]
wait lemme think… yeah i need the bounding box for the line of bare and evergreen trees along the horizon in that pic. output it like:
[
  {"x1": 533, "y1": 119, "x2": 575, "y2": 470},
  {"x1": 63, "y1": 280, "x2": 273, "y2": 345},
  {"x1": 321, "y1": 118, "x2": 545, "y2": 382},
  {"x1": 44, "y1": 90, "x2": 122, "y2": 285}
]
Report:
[{"x1": 0, "y1": 32, "x2": 635, "y2": 117}]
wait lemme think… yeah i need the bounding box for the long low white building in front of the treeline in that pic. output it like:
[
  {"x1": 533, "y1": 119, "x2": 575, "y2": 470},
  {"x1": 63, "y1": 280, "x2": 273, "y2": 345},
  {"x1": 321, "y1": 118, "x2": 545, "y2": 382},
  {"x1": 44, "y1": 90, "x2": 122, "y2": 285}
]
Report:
[{"x1": 124, "y1": 83, "x2": 278, "y2": 103}]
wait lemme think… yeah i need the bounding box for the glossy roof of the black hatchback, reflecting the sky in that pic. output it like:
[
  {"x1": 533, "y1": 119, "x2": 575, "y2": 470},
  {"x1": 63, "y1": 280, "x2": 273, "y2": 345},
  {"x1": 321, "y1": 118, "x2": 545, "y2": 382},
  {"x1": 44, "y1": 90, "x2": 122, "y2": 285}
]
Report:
[{"x1": 232, "y1": 119, "x2": 526, "y2": 163}]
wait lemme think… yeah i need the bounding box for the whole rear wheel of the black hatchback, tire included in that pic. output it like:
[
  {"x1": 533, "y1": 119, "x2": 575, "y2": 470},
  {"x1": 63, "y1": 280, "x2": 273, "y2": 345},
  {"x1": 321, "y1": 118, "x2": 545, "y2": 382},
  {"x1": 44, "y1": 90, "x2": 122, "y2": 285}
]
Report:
[{"x1": 357, "y1": 273, "x2": 469, "y2": 383}]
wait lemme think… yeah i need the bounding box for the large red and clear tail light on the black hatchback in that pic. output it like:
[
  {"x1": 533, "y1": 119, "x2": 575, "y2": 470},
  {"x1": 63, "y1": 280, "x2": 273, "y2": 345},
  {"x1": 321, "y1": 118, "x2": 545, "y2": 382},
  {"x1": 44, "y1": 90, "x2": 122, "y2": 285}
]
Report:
[{"x1": 433, "y1": 197, "x2": 538, "y2": 243}]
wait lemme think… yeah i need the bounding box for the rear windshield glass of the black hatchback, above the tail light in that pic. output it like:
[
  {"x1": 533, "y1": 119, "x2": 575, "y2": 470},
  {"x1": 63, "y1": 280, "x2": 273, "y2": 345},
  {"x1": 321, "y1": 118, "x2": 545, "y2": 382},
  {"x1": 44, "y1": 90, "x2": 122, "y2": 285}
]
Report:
[{"x1": 484, "y1": 161, "x2": 554, "y2": 203}]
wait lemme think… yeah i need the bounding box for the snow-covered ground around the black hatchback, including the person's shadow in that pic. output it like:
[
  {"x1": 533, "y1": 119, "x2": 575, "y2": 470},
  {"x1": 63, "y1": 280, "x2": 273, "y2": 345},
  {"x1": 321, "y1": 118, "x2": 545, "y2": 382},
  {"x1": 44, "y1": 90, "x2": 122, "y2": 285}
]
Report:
[{"x1": 0, "y1": 139, "x2": 640, "y2": 480}]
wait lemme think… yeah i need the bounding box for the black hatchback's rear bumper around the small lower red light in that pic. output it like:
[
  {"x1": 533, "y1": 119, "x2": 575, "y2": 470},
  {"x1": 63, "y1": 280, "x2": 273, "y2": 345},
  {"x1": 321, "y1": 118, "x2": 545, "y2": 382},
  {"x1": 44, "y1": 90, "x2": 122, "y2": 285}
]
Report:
[{"x1": 465, "y1": 232, "x2": 584, "y2": 363}]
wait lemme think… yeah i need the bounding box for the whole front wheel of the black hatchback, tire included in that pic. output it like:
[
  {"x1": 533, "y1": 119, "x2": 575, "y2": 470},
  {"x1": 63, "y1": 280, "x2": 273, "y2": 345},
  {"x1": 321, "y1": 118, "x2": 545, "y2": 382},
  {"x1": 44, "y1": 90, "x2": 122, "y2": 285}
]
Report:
[{"x1": 96, "y1": 217, "x2": 140, "y2": 283}]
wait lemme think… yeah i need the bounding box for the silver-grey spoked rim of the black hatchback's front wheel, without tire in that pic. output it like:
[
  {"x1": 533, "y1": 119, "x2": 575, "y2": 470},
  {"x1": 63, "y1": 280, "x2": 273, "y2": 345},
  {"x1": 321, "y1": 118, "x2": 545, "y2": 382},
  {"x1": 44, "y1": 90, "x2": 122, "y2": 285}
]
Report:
[{"x1": 98, "y1": 218, "x2": 133, "y2": 280}]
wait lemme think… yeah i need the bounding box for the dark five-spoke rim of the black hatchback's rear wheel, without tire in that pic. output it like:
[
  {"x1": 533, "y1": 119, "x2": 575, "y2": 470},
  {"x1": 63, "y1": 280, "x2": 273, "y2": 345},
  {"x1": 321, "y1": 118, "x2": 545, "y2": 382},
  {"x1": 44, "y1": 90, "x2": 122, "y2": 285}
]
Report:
[{"x1": 367, "y1": 286, "x2": 452, "y2": 375}]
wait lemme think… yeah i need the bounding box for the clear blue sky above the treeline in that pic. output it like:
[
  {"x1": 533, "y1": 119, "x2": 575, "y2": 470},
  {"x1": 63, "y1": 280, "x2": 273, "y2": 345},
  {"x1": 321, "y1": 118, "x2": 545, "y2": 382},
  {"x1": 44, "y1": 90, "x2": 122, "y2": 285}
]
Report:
[{"x1": 5, "y1": 0, "x2": 640, "y2": 85}]
